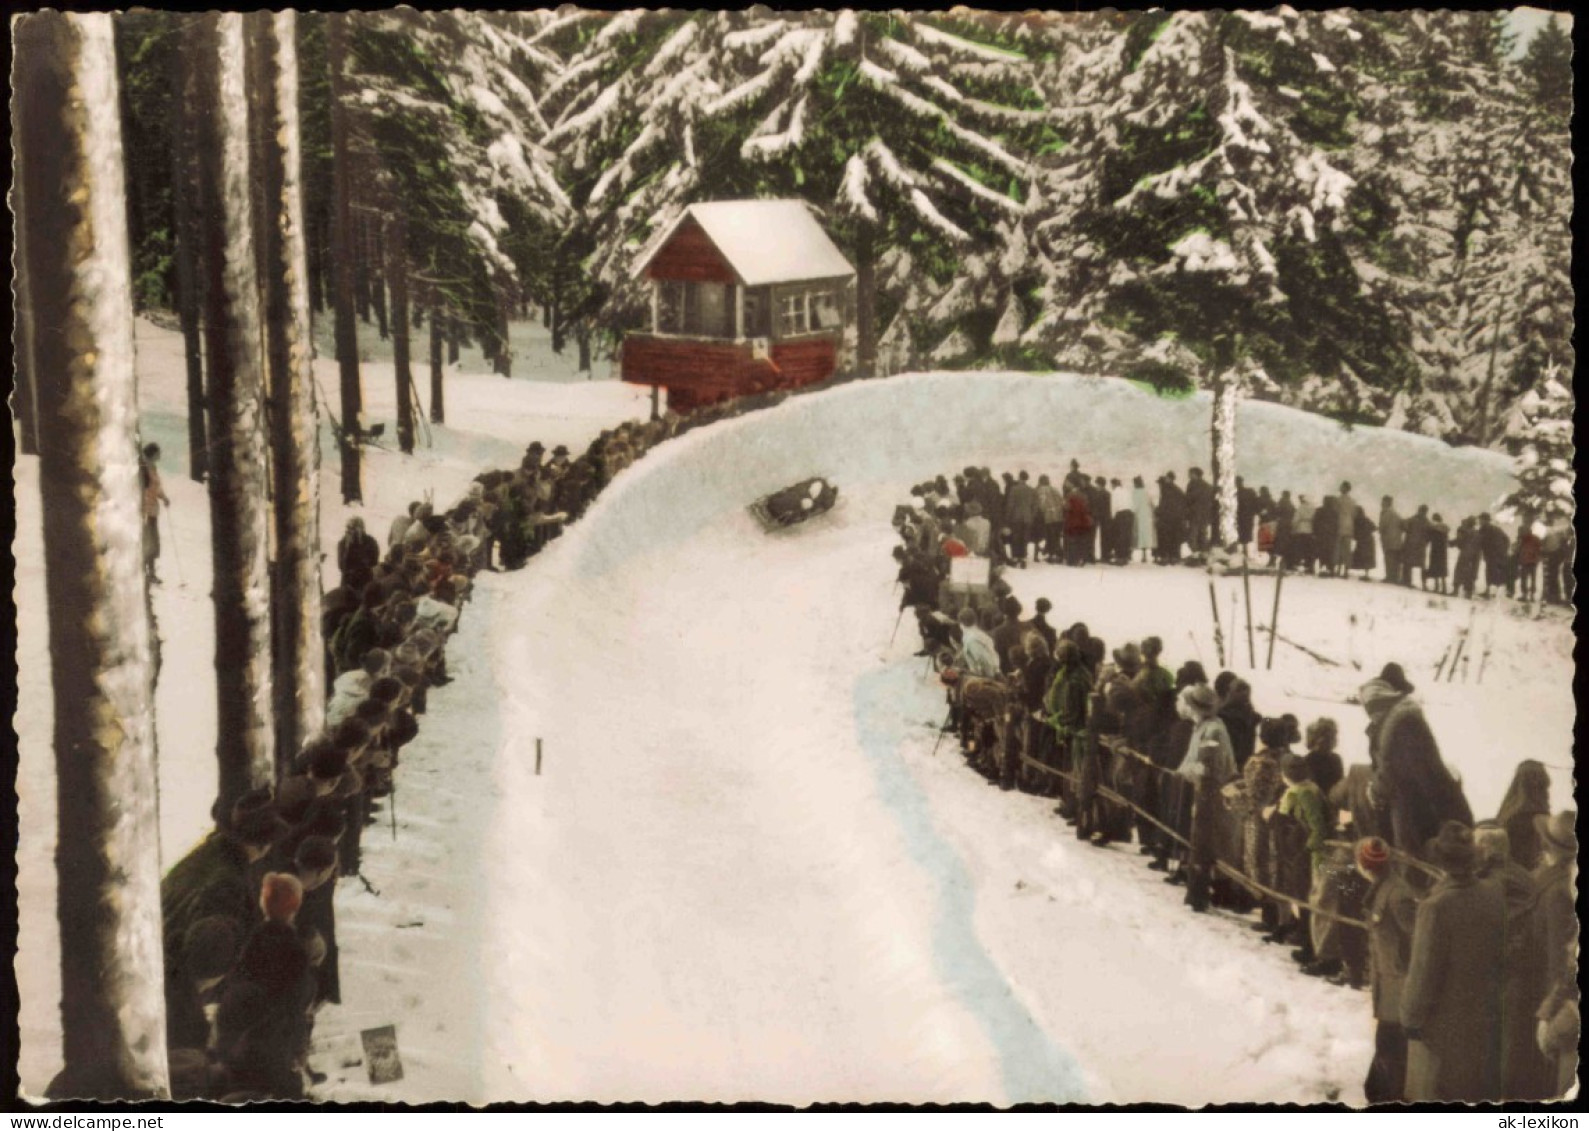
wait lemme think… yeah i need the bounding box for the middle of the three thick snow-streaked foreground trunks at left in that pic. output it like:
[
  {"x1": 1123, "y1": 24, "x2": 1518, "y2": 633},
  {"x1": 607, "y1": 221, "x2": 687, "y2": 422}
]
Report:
[{"x1": 194, "y1": 13, "x2": 275, "y2": 812}]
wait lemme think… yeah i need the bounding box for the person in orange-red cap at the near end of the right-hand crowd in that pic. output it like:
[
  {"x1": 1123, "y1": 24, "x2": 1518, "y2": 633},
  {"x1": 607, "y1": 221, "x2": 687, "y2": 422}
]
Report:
[{"x1": 1357, "y1": 837, "x2": 1417, "y2": 1104}]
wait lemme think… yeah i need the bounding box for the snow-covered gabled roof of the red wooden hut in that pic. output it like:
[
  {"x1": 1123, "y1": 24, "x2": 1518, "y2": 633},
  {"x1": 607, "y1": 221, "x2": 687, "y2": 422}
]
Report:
[{"x1": 634, "y1": 200, "x2": 855, "y2": 286}]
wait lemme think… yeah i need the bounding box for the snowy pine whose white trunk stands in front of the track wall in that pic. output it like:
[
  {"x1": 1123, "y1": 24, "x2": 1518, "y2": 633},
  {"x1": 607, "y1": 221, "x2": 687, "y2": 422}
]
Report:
[{"x1": 1036, "y1": 8, "x2": 1423, "y2": 542}]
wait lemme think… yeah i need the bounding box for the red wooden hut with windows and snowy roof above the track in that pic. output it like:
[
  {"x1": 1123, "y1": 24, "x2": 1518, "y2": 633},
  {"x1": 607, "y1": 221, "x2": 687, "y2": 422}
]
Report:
[{"x1": 623, "y1": 200, "x2": 855, "y2": 410}]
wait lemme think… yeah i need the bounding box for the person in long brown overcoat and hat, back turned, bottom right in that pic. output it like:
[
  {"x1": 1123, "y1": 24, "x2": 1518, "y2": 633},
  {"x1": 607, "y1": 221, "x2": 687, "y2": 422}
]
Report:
[{"x1": 1401, "y1": 821, "x2": 1506, "y2": 1104}]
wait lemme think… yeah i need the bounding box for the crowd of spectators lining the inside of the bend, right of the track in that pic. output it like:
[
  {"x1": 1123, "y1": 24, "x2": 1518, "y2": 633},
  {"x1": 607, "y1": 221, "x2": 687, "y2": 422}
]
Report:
[{"x1": 893, "y1": 462, "x2": 1579, "y2": 1104}]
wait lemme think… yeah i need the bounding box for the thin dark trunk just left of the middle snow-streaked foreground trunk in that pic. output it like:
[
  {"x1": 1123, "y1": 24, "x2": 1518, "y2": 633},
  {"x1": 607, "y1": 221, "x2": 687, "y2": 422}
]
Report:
[{"x1": 172, "y1": 13, "x2": 210, "y2": 483}]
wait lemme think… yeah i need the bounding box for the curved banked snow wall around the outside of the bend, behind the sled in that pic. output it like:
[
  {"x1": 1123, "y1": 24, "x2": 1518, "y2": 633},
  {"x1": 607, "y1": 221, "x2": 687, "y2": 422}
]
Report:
[{"x1": 556, "y1": 373, "x2": 1511, "y2": 577}]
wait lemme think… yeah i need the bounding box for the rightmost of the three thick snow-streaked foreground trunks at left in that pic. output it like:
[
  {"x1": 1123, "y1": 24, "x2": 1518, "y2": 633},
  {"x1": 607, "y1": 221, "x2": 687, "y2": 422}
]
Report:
[{"x1": 248, "y1": 11, "x2": 326, "y2": 775}]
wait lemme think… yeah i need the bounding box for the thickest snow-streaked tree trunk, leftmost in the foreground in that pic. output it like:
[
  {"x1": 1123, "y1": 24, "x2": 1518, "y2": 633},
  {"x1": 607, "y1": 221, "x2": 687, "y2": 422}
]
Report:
[{"x1": 13, "y1": 11, "x2": 168, "y2": 1099}]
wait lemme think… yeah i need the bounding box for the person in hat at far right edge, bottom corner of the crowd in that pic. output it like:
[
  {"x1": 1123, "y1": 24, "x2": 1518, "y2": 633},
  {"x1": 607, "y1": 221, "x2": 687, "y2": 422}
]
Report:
[{"x1": 1533, "y1": 810, "x2": 1581, "y2": 1096}]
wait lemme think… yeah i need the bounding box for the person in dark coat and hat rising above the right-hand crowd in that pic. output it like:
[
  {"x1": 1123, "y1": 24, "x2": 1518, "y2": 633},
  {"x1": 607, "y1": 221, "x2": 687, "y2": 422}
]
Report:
[{"x1": 1359, "y1": 678, "x2": 1473, "y2": 855}]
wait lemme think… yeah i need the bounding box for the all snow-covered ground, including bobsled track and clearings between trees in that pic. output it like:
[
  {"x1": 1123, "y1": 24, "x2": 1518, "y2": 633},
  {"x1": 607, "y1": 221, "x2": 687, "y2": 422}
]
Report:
[{"x1": 16, "y1": 326, "x2": 1573, "y2": 1106}]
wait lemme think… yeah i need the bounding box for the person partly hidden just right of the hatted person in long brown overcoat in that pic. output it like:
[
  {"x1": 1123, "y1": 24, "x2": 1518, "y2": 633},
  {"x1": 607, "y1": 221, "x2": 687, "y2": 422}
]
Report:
[{"x1": 1473, "y1": 821, "x2": 1556, "y2": 1099}]
